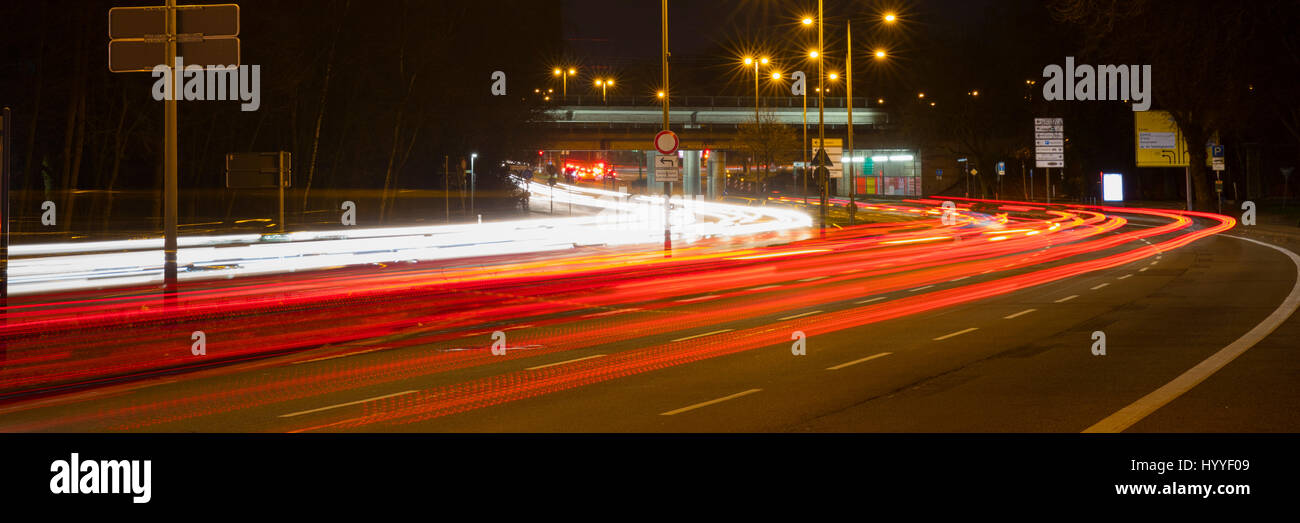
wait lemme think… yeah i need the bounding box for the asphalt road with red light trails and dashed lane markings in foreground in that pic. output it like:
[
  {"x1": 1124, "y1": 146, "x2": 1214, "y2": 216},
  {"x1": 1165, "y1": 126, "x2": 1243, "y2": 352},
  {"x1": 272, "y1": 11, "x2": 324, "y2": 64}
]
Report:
[{"x1": 0, "y1": 204, "x2": 1300, "y2": 432}]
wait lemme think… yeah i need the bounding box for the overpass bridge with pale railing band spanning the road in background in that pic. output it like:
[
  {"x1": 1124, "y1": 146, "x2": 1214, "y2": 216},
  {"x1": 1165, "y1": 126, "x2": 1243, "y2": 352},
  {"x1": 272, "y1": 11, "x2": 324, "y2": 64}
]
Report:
[{"x1": 547, "y1": 95, "x2": 893, "y2": 151}]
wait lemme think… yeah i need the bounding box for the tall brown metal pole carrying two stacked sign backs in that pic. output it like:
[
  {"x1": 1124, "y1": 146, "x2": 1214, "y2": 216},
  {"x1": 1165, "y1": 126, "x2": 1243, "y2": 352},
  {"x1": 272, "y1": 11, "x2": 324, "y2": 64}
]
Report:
[{"x1": 163, "y1": 0, "x2": 181, "y2": 303}]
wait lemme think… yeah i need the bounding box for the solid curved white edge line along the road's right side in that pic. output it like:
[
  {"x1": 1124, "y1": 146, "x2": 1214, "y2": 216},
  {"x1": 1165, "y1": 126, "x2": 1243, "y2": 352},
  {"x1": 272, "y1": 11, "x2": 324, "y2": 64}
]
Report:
[{"x1": 1083, "y1": 234, "x2": 1300, "y2": 433}]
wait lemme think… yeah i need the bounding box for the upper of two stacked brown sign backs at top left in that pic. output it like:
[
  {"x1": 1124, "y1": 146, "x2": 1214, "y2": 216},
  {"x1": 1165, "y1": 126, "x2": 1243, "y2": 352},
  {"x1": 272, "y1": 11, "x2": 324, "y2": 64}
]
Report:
[{"x1": 108, "y1": 4, "x2": 239, "y2": 40}]
